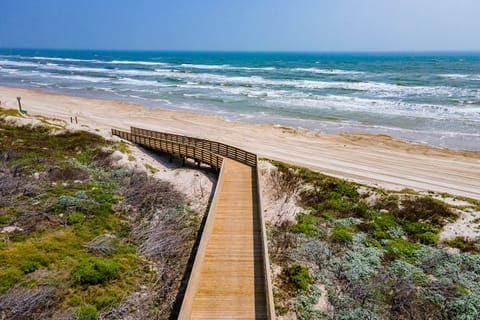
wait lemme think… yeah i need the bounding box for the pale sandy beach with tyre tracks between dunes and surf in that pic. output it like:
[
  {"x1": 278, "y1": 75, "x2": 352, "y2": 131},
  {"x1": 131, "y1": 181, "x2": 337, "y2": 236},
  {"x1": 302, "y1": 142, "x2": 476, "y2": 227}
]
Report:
[{"x1": 0, "y1": 87, "x2": 480, "y2": 199}]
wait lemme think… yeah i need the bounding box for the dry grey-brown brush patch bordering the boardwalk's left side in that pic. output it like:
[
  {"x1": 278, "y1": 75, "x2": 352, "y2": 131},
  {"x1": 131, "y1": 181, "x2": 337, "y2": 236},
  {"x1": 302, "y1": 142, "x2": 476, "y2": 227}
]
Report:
[{"x1": 117, "y1": 174, "x2": 200, "y2": 319}]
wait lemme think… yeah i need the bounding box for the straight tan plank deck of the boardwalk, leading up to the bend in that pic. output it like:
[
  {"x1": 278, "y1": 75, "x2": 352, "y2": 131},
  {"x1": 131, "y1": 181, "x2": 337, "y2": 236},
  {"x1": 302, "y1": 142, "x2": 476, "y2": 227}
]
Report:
[{"x1": 188, "y1": 159, "x2": 267, "y2": 319}]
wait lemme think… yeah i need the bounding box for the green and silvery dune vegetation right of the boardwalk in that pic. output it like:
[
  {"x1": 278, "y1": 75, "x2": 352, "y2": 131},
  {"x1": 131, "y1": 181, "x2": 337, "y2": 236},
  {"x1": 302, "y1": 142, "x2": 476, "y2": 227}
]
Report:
[{"x1": 269, "y1": 162, "x2": 480, "y2": 320}]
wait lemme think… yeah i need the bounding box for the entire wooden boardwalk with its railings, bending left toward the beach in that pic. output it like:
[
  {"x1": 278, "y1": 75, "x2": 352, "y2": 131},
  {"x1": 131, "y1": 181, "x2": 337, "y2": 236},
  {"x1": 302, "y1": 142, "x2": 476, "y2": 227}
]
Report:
[{"x1": 112, "y1": 128, "x2": 275, "y2": 320}]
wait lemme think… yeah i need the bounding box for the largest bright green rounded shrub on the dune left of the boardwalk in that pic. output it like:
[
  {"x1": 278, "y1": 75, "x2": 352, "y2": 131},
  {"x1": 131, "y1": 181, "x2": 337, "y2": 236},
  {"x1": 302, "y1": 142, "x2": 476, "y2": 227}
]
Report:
[{"x1": 72, "y1": 258, "x2": 119, "y2": 285}]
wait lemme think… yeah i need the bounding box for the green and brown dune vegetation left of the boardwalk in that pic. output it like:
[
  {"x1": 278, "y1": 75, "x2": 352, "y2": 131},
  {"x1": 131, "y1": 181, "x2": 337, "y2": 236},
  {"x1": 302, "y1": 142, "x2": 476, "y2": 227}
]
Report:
[{"x1": 0, "y1": 110, "x2": 201, "y2": 319}]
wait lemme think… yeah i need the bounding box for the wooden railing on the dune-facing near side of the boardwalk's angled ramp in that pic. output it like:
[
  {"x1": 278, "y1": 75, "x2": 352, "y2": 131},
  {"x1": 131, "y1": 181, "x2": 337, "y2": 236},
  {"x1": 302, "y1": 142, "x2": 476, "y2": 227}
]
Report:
[{"x1": 112, "y1": 129, "x2": 223, "y2": 170}]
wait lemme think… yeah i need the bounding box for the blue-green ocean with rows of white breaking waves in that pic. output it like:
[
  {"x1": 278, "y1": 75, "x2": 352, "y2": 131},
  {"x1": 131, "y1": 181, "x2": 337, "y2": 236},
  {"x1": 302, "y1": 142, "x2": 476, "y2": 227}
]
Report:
[{"x1": 0, "y1": 49, "x2": 480, "y2": 150}]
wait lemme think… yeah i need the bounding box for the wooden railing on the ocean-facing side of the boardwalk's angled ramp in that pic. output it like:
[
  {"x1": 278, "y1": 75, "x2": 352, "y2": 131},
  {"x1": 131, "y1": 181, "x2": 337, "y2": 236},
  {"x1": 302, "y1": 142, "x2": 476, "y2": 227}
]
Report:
[{"x1": 130, "y1": 127, "x2": 257, "y2": 168}]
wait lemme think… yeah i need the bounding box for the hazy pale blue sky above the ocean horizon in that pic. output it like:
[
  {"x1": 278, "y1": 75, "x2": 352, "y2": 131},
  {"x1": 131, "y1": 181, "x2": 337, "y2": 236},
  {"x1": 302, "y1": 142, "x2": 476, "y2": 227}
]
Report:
[{"x1": 0, "y1": 0, "x2": 480, "y2": 51}]
